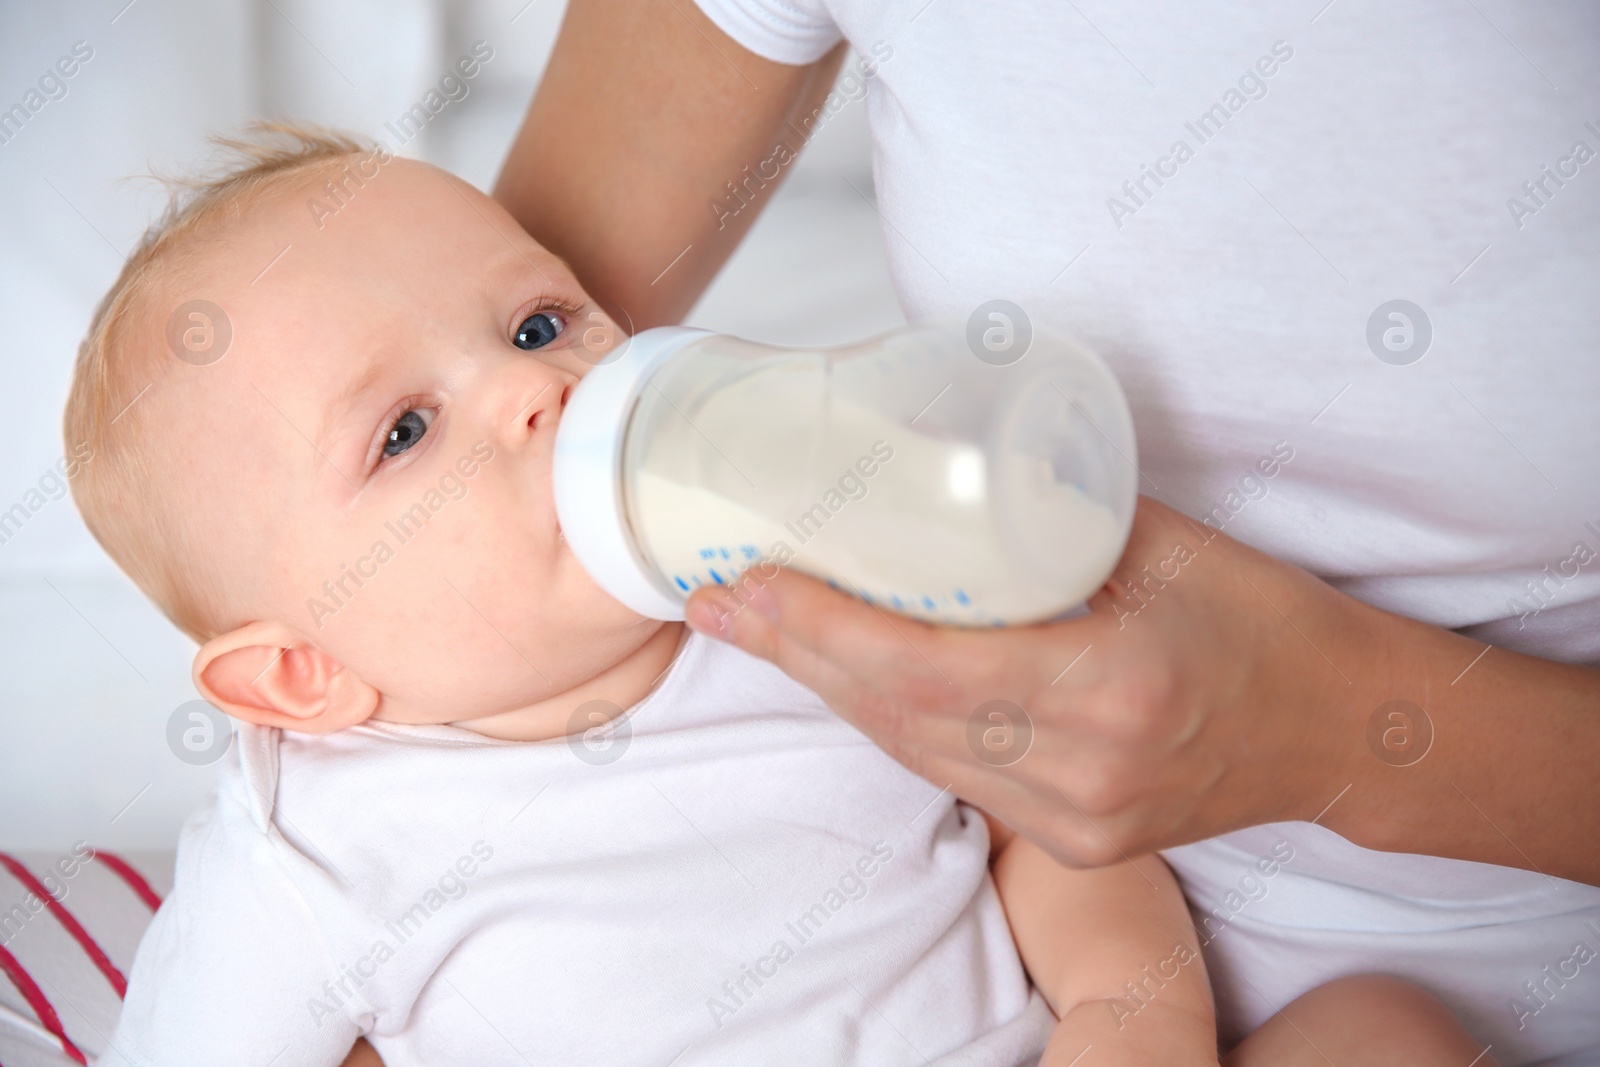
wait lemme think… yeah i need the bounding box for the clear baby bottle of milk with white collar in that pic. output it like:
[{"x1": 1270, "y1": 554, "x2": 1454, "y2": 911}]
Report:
[{"x1": 554, "y1": 325, "x2": 1138, "y2": 625}]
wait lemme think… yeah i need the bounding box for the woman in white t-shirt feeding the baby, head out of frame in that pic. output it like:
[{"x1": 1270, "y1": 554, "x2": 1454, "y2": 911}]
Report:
[{"x1": 496, "y1": 0, "x2": 1600, "y2": 1064}]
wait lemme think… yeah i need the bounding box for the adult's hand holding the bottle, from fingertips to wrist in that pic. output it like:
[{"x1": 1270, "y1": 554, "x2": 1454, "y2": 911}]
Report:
[{"x1": 690, "y1": 499, "x2": 1346, "y2": 865}]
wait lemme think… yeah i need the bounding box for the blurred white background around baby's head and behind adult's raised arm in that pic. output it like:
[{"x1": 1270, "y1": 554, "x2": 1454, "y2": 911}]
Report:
[{"x1": 0, "y1": 0, "x2": 901, "y2": 849}]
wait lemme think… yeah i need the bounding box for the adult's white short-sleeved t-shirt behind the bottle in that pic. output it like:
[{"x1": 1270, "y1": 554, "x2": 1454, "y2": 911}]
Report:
[{"x1": 699, "y1": 0, "x2": 1600, "y2": 1064}]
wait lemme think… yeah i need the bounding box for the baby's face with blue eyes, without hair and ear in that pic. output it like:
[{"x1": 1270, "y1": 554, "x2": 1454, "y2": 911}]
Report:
[{"x1": 152, "y1": 160, "x2": 662, "y2": 735}]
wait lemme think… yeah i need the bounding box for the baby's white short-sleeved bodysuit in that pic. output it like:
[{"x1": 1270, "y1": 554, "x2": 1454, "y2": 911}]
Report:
[{"x1": 99, "y1": 635, "x2": 1054, "y2": 1067}]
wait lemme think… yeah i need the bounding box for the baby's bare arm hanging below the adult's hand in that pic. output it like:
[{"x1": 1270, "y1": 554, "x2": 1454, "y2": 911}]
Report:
[{"x1": 986, "y1": 816, "x2": 1218, "y2": 1067}]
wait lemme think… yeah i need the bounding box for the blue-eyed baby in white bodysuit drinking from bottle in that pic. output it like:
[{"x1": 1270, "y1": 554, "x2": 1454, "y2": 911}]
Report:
[{"x1": 66, "y1": 126, "x2": 1488, "y2": 1067}]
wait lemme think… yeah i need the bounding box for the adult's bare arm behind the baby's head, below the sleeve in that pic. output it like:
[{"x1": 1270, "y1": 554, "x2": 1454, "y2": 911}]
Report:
[{"x1": 494, "y1": 0, "x2": 845, "y2": 333}]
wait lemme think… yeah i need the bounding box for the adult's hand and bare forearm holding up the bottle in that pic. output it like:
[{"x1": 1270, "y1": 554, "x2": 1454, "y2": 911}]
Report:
[{"x1": 688, "y1": 498, "x2": 1600, "y2": 881}]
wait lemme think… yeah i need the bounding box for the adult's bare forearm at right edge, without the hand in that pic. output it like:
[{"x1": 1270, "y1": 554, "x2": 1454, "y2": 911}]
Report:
[{"x1": 1301, "y1": 591, "x2": 1600, "y2": 885}]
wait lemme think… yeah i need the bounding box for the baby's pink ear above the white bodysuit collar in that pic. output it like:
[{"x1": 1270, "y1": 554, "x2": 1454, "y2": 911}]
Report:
[{"x1": 194, "y1": 622, "x2": 379, "y2": 734}]
